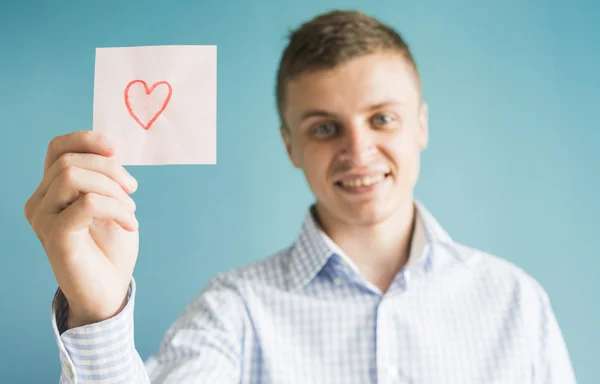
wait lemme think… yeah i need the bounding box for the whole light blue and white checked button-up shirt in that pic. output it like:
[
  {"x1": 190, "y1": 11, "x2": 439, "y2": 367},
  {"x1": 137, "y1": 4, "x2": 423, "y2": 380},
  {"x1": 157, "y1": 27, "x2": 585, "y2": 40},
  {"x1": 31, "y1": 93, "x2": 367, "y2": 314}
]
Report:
[{"x1": 52, "y1": 202, "x2": 576, "y2": 384}]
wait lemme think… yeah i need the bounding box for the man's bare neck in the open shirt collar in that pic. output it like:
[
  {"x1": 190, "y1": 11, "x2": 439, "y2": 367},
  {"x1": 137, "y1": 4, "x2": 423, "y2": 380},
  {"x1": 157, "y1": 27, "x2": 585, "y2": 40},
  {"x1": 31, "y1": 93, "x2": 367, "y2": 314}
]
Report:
[{"x1": 316, "y1": 200, "x2": 415, "y2": 292}]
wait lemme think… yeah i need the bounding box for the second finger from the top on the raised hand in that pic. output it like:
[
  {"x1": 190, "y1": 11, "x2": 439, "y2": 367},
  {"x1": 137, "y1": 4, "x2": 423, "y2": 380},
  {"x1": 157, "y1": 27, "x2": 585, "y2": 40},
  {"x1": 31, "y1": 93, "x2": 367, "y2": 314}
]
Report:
[{"x1": 39, "y1": 152, "x2": 137, "y2": 196}]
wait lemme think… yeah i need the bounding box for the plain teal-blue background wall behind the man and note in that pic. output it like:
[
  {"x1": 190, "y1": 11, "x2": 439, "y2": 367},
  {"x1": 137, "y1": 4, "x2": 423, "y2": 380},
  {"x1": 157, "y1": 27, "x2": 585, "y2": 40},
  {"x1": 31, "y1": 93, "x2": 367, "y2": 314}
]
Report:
[{"x1": 0, "y1": 0, "x2": 600, "y2": 383}]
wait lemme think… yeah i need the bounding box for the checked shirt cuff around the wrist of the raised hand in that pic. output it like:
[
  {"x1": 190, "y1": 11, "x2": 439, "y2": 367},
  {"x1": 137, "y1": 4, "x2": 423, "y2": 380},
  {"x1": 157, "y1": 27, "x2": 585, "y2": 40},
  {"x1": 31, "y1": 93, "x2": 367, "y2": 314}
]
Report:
[{"x1": 52, "y1": 278, "x2": 136, "y2": 382}]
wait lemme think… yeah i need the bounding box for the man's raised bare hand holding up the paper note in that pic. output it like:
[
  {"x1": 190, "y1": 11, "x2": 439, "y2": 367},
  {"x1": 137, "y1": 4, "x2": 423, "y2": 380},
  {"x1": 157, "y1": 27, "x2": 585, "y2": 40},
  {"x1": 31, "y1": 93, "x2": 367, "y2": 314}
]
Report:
[{"x1": 25, "y1": 131, "x2": 139, "y2": 328}]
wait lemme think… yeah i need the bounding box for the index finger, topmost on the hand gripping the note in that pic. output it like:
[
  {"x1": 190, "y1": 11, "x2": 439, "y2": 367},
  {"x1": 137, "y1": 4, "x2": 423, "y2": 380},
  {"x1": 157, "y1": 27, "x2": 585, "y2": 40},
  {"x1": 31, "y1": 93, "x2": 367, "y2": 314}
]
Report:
[{"x1": 44, "y1": 131, "x2": 114, "y2": 174}]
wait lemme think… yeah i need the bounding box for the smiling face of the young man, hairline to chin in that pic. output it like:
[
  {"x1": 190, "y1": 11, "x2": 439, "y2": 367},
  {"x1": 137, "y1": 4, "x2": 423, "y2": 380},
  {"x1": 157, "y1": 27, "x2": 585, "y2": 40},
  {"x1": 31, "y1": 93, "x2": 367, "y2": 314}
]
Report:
[{"x1": 282, "y1": 53, "x2": 428, "y2": 225}]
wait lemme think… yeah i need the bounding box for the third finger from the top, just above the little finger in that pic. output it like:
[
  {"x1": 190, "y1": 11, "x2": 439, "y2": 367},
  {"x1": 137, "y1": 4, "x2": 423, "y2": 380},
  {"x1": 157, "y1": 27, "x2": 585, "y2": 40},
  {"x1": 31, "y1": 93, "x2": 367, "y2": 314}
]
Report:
[{"x1": 40, "y1": 167, "x2": 135, "y2": 214}]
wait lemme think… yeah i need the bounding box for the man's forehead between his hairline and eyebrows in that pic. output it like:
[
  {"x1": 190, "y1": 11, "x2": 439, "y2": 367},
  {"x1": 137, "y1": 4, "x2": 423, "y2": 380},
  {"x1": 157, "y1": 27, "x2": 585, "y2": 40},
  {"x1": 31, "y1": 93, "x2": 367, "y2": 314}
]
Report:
[{"x1": 285, "y1": 53, "x2": 420, "y2": 124}]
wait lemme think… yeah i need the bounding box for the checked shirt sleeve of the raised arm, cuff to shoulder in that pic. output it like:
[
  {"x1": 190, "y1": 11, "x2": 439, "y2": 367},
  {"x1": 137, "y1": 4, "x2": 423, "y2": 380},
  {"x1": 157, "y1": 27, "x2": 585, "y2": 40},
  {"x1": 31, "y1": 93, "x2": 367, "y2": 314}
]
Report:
[{"x1": 52, "y1": 278, "x2": 246, "y2": 384}]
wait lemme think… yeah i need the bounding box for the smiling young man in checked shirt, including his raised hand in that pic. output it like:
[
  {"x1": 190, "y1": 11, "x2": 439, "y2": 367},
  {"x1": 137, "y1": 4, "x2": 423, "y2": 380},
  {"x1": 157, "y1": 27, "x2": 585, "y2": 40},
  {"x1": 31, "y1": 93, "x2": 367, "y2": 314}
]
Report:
[{"x1": 25, "y1": 11, "x2": 575, "y2": 384}]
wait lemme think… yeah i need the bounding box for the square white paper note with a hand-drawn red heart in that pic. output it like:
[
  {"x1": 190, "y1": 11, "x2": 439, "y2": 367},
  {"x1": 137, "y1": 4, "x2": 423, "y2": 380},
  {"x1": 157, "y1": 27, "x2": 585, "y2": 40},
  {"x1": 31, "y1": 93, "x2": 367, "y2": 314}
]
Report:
[{"x1": 93, "y1": 45, "x2": 217, "y2": 165}]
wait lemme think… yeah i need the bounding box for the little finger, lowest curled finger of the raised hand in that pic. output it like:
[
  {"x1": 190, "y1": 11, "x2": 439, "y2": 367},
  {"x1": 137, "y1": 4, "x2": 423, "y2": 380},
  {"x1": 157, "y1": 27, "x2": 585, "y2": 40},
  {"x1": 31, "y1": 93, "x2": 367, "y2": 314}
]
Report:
[{"x1": 55, "y1": 193, "x2": 138, "y2": 232}]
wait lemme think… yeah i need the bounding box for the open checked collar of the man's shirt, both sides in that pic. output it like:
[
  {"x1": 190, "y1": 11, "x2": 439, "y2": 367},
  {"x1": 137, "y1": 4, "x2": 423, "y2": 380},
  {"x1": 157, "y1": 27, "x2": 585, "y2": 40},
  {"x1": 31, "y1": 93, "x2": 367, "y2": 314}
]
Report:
[{"x1": 288, "y1": 201, "x2": 453, "y2": 288}]
